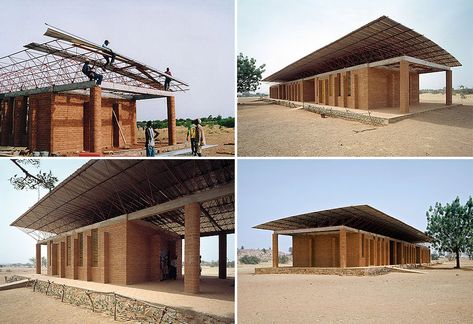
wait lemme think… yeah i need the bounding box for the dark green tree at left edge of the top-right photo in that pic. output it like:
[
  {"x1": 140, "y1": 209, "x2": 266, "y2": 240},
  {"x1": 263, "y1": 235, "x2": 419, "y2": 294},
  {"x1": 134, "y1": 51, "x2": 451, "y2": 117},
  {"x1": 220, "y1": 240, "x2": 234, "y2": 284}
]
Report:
[{"x1": 237, "y1": 53, "x2": 266, "y2": 93}]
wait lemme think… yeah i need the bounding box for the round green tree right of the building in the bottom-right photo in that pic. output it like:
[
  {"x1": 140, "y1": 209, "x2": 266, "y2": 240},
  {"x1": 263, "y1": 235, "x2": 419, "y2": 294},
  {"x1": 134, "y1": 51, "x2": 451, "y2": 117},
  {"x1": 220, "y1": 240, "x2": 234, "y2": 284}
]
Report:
[{"x1": 426, "y1": 196, "x2": 473, "y2": 268}]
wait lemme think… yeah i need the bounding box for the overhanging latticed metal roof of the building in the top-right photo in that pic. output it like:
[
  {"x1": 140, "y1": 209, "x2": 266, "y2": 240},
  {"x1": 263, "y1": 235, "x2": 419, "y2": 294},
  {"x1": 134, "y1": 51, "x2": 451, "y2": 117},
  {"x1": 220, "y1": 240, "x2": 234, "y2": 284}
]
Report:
[{"x1": 263, "y1": 16, "x2": 461, "y2": 82}]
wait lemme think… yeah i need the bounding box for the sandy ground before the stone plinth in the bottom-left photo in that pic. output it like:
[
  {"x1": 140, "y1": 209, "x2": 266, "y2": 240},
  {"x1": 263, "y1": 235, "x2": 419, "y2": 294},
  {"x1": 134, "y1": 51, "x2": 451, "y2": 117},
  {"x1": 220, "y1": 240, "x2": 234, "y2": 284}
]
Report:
[{"x1": 0, "y1": 288, "x2": 119, "y2": 324}]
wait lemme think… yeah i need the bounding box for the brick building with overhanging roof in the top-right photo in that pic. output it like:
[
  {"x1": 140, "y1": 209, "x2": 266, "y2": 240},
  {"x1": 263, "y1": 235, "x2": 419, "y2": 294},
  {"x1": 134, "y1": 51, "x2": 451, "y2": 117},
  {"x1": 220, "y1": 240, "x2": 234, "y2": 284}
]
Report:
[{"x1": 263, "y1": 16, "x2": 461, "y2": 113}]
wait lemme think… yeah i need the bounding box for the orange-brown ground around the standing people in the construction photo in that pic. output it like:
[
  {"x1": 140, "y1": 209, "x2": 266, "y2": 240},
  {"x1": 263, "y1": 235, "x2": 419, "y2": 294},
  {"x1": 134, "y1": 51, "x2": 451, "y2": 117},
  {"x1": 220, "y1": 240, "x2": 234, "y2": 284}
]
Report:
[{"x1": 137, "y1": 126, "x2": 235, "y2": 157}]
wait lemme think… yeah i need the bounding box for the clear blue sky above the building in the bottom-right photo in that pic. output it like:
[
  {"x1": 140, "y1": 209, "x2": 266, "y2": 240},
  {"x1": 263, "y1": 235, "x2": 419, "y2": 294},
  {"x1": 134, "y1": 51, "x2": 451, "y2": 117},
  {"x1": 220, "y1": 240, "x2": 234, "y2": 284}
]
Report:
[{"x1": 237, "y1": 159, "x2": 473, "y2": 251}]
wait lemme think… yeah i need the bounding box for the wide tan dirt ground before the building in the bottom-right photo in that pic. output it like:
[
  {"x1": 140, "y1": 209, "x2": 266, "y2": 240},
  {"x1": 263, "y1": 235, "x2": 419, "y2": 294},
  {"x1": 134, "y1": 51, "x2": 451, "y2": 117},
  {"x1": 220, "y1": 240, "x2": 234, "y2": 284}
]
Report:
[{"x1": 237, "y1": 260, "x2": 473, "y2": 323}]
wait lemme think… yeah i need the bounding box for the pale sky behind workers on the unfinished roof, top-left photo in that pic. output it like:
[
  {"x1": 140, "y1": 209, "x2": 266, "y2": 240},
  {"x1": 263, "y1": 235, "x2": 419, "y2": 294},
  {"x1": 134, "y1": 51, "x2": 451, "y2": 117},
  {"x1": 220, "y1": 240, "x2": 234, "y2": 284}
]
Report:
[{"x1": 0, "y1": 0, "x2": 236, "y2": 120}]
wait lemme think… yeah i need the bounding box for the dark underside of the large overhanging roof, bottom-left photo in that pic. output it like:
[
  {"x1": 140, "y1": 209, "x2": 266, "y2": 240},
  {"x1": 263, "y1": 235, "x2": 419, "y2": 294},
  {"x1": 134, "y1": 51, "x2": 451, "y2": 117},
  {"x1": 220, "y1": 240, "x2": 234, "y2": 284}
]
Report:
[{"x1": 11, "y1": 159, "x2": 235, "y2": 239}]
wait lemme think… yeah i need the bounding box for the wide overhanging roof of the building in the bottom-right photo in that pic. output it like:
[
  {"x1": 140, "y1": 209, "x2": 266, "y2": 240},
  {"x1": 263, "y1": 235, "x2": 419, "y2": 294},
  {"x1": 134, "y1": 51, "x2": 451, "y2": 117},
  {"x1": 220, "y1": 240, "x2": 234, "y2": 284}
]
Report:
[{"x1": 254, "y1": 205, "x2": 431, "y2": 243}]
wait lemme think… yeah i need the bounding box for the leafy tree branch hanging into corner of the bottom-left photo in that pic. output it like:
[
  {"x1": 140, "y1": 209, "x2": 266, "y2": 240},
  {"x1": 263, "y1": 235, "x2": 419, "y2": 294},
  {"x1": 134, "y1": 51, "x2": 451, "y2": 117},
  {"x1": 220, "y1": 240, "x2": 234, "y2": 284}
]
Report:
[{"x1": 9, "y1": 159, "x2": 58, "y2": 191}]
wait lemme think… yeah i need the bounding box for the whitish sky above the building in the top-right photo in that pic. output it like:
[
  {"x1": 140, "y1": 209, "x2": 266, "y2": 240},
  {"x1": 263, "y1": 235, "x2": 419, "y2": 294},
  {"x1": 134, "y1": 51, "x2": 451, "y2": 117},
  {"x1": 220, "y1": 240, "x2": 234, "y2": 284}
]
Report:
[{"x1": 237, "y1": 0, "x2": 473, "y2": 93}]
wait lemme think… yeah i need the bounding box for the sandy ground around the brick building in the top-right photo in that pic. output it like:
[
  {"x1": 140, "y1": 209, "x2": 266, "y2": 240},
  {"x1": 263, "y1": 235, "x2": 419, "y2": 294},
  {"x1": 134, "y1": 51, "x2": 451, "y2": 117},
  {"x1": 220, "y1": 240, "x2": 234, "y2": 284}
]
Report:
[{"x1": 238, "y1": 94, "x2": 473, "y2": 157}]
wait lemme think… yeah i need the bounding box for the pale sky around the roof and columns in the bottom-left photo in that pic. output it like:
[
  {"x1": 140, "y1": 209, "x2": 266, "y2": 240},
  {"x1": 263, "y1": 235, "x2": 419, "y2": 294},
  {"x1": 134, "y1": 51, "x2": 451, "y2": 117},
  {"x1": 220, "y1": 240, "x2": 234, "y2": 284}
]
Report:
[{"x1": 0, "y1": 158, "x2": 235, "y2": 264}]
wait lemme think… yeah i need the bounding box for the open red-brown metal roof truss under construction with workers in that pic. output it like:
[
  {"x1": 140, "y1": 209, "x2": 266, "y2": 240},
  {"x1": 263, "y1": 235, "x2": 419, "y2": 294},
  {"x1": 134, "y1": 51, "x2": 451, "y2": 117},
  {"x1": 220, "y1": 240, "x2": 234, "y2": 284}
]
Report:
[{"x1": 0, "y1": 27, "x2": 188, "y2": 94}]
